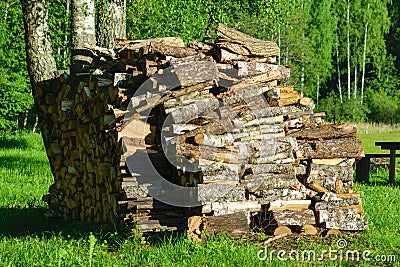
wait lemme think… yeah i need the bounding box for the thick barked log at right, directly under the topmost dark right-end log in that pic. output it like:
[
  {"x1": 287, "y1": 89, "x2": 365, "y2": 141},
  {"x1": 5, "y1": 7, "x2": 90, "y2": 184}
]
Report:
[{"x1": 296, "y1": 138, "x2": 364, "y2": 159}]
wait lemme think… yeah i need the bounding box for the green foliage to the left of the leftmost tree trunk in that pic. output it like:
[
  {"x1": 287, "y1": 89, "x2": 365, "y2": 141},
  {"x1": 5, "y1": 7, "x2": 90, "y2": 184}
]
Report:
[{"x1": 0, "y1": 0, "x2": 33, "y2": 131}]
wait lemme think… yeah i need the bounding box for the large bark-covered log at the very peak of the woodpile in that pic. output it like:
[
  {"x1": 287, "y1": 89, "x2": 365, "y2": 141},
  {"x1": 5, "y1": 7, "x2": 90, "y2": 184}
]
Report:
[{"x1": 217, "y1": 23, "x2": 279, "y2": 57}]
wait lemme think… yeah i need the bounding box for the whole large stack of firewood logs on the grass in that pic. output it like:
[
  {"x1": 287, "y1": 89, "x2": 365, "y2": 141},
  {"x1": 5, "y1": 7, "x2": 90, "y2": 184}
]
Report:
[{"x1": 40, "y1": 24, "x2": 366, "y2": 238}]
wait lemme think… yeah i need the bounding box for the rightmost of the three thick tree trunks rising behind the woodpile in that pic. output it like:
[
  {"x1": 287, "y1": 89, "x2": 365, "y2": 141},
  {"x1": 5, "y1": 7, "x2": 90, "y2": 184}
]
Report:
[{"x1": 96, "y1": 0, "x2": 126, "y2": 48}]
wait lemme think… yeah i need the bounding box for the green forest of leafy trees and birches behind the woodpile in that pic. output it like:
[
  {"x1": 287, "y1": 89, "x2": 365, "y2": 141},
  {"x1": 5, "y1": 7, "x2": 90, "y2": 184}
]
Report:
[{"x1": 0, "y1": 0, "x2": 400, "y2": 132}]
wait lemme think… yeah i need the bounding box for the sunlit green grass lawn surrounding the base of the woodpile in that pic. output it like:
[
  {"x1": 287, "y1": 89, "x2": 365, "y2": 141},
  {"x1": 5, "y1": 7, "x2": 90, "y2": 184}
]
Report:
[{"x1": 0, "y1": 131, "x2": 400, "y2": 266}]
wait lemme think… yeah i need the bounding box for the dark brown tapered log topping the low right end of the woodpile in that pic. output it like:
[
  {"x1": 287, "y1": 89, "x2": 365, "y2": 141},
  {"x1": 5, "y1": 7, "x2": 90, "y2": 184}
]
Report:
[{"x1": 286, "y1": 123, "x2": 357, "y2": 140}]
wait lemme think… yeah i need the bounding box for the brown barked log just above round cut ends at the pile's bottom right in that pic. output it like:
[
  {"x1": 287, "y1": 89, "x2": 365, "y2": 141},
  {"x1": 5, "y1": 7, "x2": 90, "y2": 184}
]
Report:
[{"x1": 267, "y1": 210, "x2": 315, "y2": 226}]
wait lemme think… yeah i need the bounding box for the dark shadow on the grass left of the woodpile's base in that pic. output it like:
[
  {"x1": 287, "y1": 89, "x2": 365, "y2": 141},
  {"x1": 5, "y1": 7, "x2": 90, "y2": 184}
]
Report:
[{"x1": 0, "y1": 208, "x2": 115, "y2": 238}]
